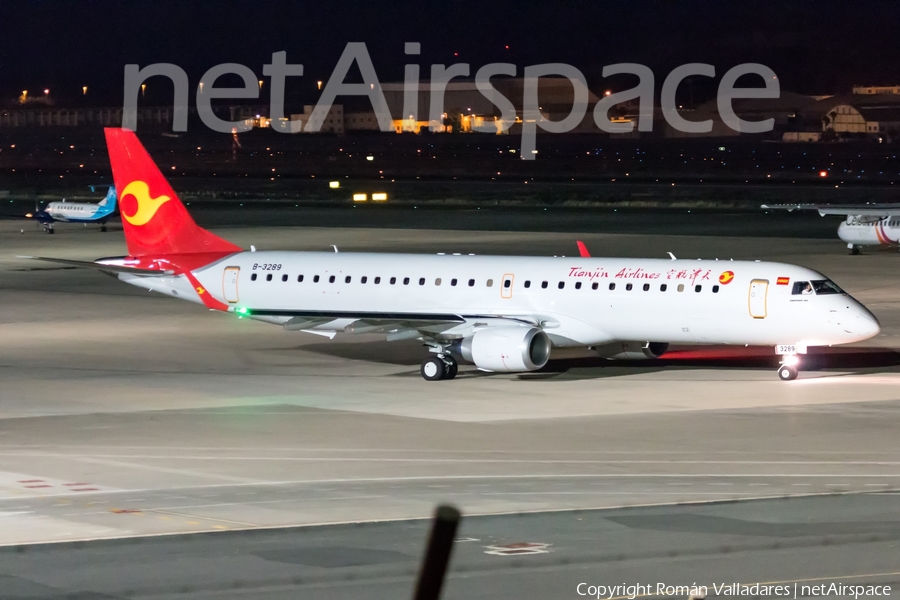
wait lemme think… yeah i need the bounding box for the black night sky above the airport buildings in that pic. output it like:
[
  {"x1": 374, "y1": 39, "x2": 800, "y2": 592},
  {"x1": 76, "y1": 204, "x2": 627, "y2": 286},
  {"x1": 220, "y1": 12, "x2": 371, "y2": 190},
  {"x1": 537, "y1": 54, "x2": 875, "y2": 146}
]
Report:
[{"x1": 0, "y1": 0, "x2": 900, "y2": 105}]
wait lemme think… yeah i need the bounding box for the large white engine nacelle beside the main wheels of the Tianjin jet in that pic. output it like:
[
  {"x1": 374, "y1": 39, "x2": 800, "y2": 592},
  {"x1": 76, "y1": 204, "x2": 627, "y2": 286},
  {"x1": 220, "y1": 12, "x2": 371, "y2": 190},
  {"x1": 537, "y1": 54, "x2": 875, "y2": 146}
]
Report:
[{"x1": 459, "y1": 327, "x2": 550, "y2": 373}]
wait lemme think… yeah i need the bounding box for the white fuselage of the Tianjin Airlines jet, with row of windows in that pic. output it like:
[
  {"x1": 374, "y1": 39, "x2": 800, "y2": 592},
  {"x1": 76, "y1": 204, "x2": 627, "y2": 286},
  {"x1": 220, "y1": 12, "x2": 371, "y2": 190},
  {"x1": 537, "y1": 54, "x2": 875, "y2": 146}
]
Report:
[{"x1": 119, "y1": 252, "x2": 879, "y2": 348}]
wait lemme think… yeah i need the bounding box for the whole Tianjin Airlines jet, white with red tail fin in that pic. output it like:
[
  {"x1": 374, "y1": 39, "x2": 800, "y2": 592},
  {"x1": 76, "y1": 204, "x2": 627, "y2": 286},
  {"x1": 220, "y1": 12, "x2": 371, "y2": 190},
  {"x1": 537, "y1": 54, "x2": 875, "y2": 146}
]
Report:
[{"x1": 24, "y1": 129, "x2": 879, "y2": 381}]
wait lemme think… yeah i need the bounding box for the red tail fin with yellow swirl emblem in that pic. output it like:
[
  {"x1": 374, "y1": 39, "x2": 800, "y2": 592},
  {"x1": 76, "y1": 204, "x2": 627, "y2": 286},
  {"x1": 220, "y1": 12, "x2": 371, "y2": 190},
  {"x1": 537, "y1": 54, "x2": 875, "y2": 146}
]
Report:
[{"x1": 105, "y1": 128, "x2": 241, "y2": 256}]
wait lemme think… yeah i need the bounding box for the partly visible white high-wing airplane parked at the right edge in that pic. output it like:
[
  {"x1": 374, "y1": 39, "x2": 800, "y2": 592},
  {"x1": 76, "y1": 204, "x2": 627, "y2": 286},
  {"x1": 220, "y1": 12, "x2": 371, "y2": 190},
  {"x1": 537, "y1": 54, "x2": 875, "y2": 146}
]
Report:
[{"x1": 761, "y1": 204, "x2": 900, "y2": 255}]
